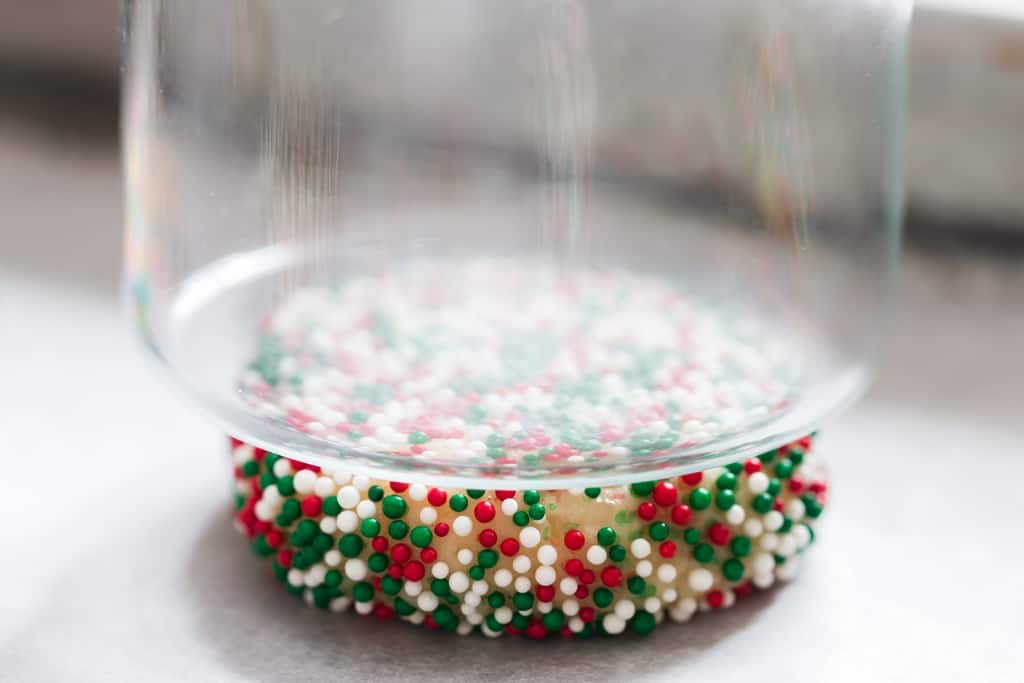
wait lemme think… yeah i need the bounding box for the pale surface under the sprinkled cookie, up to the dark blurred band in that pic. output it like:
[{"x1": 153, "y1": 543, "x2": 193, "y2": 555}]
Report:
[{"x1": 0, "y1": 124, "x2": 1024, "y2": 683}]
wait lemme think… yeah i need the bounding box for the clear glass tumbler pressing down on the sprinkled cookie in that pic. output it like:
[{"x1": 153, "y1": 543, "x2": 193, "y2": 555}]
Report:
[{"x1": 124, "y1": 0, "x2": 910, "y2": 488}]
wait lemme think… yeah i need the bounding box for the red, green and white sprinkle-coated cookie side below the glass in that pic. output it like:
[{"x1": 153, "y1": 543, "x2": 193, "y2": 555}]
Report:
[{"x1": 230, "y1": 436, "x2": 827, "y2": 639}]
